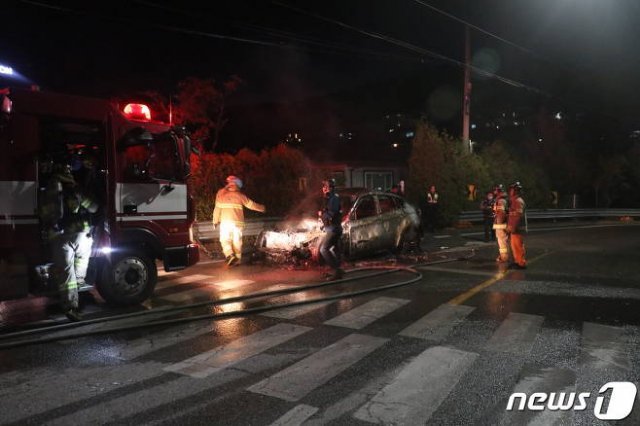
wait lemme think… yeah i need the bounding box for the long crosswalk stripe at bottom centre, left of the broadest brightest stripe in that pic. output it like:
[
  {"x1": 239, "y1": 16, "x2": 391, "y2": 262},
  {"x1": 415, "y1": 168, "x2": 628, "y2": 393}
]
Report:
[{"x1": 247, "y1": 334, "x2": 389, "y2": 401}]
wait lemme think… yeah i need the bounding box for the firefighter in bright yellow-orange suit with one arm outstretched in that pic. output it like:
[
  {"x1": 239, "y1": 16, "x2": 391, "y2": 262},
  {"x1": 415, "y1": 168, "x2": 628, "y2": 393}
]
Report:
[{"x1": 213, "y1": 175, "x2": 266, "y2": 266}]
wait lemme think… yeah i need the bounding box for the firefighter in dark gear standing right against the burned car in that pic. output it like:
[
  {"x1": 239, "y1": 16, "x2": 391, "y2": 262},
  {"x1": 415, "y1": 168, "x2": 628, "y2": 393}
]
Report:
[{"x1": 318, "y1": 179, "x2": 344, "y2": 280}]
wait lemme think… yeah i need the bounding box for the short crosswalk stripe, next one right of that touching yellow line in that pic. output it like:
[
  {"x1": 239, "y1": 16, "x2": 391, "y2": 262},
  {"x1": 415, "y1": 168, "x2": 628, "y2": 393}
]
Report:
[{"x1": 487, "y1": 312, "x2": 544, "y2": 354}]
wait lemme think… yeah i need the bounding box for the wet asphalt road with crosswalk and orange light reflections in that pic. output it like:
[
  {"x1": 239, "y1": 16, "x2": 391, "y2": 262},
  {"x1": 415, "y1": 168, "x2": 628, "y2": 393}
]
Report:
[{"x1": 0, "y1": 224, "x2": 640, "y2": 425}]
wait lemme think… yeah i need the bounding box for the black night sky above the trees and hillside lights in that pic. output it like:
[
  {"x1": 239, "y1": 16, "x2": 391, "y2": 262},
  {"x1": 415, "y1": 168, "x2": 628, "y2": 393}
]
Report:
[{"x1": 0, "y1": 0, "x2": 640, "y2": 154}]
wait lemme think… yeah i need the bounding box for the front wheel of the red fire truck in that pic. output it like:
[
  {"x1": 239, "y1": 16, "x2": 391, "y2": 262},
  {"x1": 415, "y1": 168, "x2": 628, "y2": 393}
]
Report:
[{"x1": 98, "y1": 252, "x2": 158, "y2": 305}]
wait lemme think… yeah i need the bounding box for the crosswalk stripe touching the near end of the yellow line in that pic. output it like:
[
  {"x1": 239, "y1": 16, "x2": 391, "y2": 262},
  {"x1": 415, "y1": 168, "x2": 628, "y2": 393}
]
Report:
[{"x1": 399, "y1": 304, "x2": 475, "y2": 340}]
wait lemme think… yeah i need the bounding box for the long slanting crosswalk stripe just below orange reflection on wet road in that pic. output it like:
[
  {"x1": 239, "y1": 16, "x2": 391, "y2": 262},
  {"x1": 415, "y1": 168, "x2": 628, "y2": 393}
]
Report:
[{"x1": 164, "y1": 324, "x2": 311, "y2": 379}]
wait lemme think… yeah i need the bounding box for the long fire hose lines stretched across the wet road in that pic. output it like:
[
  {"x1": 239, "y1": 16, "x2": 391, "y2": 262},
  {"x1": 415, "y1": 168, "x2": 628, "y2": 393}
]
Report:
[{"x1": 0, "y1": 250, "x2": 475, "y2": 349}]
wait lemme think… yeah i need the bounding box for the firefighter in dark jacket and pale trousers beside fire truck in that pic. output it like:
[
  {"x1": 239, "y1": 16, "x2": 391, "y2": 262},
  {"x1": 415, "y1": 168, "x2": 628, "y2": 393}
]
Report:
[{"x1": 41, "y1": 162, "x2": 98, "y2": 321}]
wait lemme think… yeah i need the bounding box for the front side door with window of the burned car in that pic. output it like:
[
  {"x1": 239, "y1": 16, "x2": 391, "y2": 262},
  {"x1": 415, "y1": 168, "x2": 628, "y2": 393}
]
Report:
[{"x1": 349, "y1": 195, "x2": 382, "y2": 256}]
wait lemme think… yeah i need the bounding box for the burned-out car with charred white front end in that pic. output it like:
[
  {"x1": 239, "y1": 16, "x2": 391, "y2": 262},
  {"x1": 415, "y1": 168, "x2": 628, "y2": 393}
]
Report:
[{"x1": 256, "y1": 188, "x2": 420, "y2": 262}]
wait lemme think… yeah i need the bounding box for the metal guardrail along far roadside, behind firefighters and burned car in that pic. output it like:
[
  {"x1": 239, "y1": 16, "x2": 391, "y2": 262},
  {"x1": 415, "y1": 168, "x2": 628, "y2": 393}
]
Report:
[{"x1": 194, "y1": 209, "x2": 640, "y2": 241}]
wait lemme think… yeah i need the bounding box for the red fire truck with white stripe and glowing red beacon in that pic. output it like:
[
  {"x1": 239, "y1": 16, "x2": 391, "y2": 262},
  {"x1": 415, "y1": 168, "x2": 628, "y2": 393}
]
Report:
[{"x1": 0, "y1": 89, "x2": 199, "y2": 305}]
